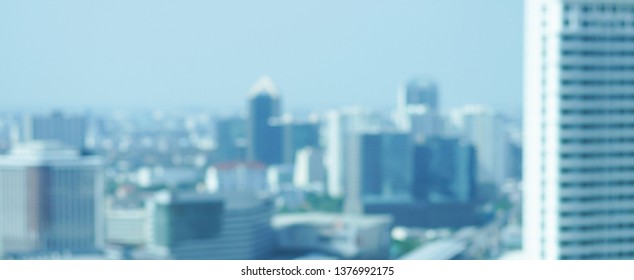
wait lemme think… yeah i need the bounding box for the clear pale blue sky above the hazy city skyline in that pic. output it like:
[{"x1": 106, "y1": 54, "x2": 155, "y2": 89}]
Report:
[{"x1": 0, "y1": 0, "x2": 522, "y2": 115}]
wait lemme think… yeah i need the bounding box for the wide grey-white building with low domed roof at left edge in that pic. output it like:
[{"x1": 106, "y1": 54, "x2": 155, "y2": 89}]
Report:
[{"x1": 0, "y1": 141, "x2": 104, "y2": 255}]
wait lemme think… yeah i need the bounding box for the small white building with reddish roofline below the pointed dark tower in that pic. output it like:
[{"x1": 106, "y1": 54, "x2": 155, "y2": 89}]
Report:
[{"x1": 205, "y1": 162, "x2": 269, "y2": 193}]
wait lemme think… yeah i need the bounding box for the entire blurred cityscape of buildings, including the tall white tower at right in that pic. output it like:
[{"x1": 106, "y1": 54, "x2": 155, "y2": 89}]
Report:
[{"x1": 0, "y1": 0, "x2": 634, "y2": 259}]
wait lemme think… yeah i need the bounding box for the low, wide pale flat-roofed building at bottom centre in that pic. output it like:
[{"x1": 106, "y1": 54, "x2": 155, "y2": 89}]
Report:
[{"x1": 273, "y1": 213, "x2": 392, "y2": 260}]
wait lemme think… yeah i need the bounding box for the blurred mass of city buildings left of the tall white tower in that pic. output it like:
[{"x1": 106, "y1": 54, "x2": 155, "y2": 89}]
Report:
[{"x1": 0, "y1": 72, "x2": 519, "y2": 259}]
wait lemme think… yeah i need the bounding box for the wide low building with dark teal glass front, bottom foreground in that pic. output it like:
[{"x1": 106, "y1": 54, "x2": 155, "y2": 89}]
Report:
[{"x1": 141, "y1": 192, "x2": 276, "y2": 260}]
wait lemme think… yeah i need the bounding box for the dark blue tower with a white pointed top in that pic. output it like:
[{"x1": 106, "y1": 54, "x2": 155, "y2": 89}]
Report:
[{"x1": 247, "y1": 76, "x2": 283, "y2": 165}]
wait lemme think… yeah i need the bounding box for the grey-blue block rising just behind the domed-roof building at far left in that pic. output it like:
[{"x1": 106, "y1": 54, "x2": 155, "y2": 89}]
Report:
[{"x1": 22, "y1": 112, "x2": 87, "y2": 150}]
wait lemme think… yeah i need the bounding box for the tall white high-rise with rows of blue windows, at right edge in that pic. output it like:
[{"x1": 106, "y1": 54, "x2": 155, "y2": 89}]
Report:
[{"x1": 523, "y1": 0, "x2": 634, "y2": 259}]
